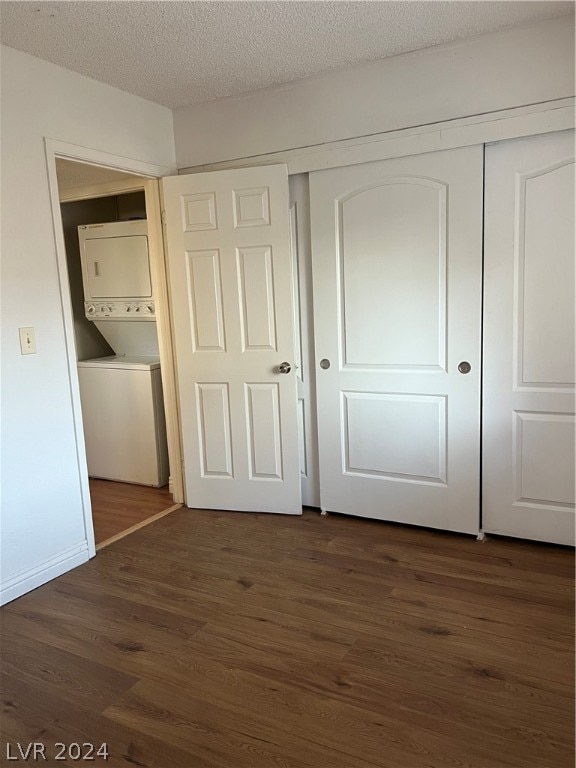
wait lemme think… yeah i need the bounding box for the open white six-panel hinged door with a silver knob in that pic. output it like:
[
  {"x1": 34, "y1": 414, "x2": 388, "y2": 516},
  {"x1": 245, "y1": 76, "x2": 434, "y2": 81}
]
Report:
[{"x1": 162, "y1": 165, "x2": 302, "y2": 514}]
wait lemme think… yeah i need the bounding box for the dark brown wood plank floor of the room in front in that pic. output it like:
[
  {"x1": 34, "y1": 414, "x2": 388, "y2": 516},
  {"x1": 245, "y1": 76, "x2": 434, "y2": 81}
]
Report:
[{"x1": 0, "y1": 509, "x2": 574, "y2": 768}]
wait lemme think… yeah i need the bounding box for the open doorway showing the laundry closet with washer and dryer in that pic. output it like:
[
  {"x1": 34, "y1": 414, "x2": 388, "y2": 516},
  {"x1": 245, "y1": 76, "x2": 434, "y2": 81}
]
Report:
[{"x1": 55, "y1": 157, "x2": 181, "y2": 550}]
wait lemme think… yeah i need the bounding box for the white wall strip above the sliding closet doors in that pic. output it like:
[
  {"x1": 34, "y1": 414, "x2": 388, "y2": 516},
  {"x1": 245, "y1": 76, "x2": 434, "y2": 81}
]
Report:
[{"x1": 174, "y1": 16, "x2": 574, "y2": 169}]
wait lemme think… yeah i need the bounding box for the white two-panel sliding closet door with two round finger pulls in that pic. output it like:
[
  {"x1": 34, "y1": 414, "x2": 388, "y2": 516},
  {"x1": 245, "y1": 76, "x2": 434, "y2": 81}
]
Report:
[{"x1": 310, "y1": 147, "x2": 483, "y2": 533}]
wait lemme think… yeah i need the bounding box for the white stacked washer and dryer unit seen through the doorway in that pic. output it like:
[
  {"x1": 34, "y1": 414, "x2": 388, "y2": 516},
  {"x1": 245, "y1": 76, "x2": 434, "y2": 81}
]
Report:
[{"x1": 78, "y1": 220, "x2": 169, "y2": 487}]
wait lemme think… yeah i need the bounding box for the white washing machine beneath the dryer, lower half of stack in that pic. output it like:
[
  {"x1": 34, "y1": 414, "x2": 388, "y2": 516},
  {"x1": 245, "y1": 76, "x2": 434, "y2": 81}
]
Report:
[{"x1": 78, "y1": 355, "x2": 169, "y2": 487}]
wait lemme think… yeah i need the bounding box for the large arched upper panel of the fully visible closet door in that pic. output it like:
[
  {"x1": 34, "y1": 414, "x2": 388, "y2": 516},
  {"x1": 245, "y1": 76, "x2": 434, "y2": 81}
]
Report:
[{"x1": 336, "y1": 178, "x2": 446, "y2": 369}]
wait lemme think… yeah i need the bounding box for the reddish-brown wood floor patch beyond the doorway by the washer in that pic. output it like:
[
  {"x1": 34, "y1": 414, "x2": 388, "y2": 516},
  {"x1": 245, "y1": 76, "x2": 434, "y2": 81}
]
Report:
[{"x1": 90, "y1": 478, "x2": 174, "y2": 545}]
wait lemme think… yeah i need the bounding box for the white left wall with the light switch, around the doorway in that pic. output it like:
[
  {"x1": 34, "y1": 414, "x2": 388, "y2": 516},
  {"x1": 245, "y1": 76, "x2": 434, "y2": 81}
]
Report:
[{"x1": 1, "y1": 47, "x2": 174, "y2": 599}]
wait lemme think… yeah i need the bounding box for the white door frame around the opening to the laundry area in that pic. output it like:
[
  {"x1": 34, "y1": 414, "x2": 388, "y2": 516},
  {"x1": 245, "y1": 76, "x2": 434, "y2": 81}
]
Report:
[{"x1": 44, "y1": 137, "x2": 184, "y2": 557}]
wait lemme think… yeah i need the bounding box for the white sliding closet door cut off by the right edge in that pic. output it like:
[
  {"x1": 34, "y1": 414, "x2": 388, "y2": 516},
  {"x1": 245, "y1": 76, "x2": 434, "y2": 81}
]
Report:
[{"x1": 482, "y1": 131, "x2": 575, "y2": 544}]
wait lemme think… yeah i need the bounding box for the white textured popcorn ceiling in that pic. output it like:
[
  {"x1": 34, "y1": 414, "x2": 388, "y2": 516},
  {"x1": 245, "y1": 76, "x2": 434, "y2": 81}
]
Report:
[{"x1": 0, "y1": 0, "x2": 574, "y2": 109}]
